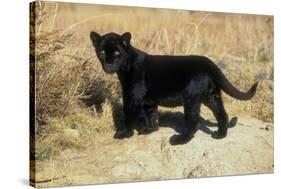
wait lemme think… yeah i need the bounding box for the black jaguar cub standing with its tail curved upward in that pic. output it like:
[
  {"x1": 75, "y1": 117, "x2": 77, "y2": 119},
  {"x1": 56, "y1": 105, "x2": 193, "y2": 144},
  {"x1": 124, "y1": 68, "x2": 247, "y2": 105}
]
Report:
[{"x1": 90, "y1": 32, "x2": 258, "y2": 145}]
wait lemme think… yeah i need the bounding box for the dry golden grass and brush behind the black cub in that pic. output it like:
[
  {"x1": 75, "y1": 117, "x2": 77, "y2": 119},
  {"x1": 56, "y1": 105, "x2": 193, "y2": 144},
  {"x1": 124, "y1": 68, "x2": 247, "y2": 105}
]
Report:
[{"x1": 31, "y1": 2, "x2": 273, "y2": 162}]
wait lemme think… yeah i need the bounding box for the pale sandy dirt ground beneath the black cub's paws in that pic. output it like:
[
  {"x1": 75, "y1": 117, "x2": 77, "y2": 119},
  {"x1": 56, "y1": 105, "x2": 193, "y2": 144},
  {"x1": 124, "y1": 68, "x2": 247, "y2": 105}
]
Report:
[{"x1": 32, "y1": 112, "x2": 274, "y2": 187}]
